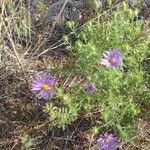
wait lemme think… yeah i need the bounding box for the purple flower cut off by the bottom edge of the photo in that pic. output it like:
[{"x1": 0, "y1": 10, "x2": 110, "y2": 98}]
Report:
[{"x1": 97, "y1": 134, "x2": 118, "y2": 150}]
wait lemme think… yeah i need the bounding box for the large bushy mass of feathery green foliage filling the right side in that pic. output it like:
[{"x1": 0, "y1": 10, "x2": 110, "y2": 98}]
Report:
[{"x1": 44, "y1": 3, "x2": 150, "y2": 140}]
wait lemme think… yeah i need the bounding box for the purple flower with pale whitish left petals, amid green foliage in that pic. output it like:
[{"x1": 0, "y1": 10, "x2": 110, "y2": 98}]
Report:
[{"x1": 100, "y1": 49, "x2": 121, "y2": 69}]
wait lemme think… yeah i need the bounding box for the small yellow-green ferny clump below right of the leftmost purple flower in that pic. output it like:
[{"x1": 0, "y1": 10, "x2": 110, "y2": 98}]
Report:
[{"x1": 44, "y1": 88, "x2": 78, "y2": 129}]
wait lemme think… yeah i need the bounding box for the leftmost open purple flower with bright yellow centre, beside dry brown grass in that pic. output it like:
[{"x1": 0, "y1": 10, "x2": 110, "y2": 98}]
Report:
[{"x1": 31, "y1": 74, "x2": 55, "y2": 99}]
